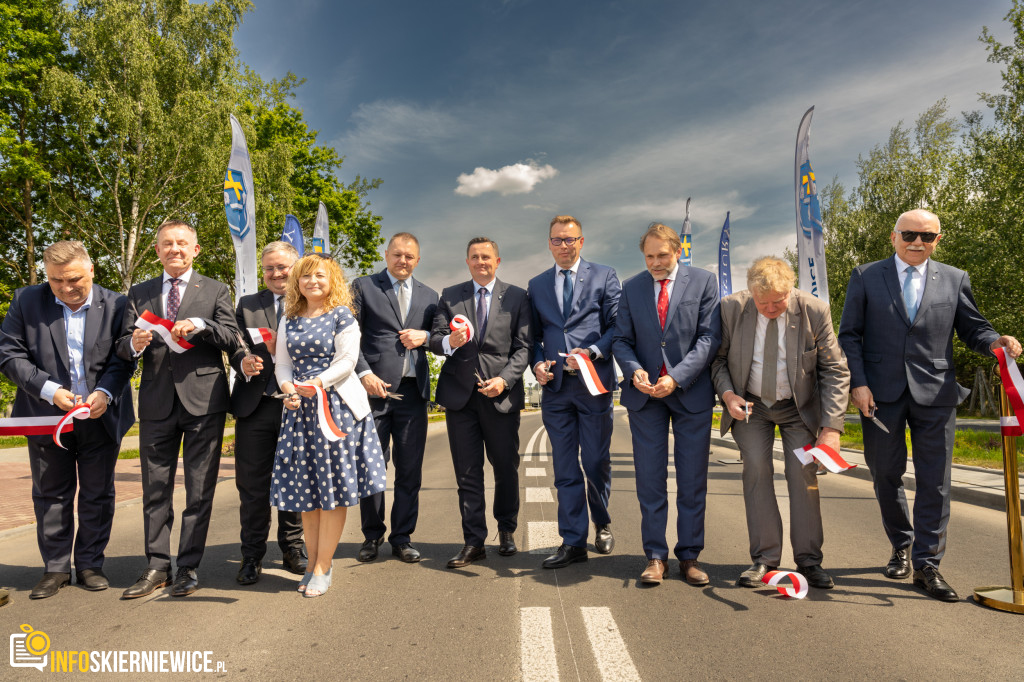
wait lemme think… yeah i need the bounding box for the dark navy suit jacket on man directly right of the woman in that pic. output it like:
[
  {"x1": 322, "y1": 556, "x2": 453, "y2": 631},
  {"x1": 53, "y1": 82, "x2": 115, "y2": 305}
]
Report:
[{"x1": 352, "y1": 269, "x2": 437, "y2": 400}]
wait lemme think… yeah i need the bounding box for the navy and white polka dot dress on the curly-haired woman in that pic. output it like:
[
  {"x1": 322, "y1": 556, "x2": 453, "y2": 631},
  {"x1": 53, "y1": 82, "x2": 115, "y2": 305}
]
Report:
[{"x1": 270, "y1": 307, "x2": 387, "y2": 512}]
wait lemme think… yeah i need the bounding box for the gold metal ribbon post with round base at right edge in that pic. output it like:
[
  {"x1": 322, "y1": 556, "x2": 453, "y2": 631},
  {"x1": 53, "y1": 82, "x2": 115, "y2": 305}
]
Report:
[{"x1": 974, "y1": 387, "x2": 1024, "y2": 613}]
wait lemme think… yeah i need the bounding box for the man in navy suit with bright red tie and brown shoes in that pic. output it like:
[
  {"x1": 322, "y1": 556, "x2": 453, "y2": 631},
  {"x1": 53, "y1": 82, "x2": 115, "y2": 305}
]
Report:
[{"x1": 612, "y1": 223, "x2": 721, "y2": 586}]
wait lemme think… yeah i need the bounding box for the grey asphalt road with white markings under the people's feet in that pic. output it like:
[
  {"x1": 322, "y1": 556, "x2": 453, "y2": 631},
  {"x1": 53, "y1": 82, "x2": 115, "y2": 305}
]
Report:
[{"x1": 0, "y1": 405, "x2": 1024, "y2": 680}]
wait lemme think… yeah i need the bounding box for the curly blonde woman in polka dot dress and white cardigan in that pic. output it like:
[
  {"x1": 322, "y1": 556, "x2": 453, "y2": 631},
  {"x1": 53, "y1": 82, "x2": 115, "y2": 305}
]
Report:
[{"x1": 270, "y1": 254, "x2": 386, "y2": 597}]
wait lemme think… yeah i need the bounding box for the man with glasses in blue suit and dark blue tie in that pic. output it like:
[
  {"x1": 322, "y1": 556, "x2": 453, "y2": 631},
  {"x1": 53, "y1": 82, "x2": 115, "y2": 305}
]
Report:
[{"x1": 526, "y1": 215, "x2": 622, "y2": 568}]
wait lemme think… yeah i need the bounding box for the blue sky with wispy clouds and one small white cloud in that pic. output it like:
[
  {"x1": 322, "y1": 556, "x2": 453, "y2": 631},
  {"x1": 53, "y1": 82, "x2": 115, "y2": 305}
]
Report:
[{"x1": 236, "y1": 0, "x2": 1010, "y2": 290}]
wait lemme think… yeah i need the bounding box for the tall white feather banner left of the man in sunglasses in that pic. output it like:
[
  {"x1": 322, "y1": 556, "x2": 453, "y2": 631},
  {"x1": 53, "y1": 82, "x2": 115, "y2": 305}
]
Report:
[{"x1": 794, "y1": 106, "x2": 828, "y2": 303}]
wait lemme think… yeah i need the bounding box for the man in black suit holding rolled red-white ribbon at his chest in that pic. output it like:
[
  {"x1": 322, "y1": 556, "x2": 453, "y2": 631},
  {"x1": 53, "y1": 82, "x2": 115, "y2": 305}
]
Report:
[{"x1": 430, "y1": 237, "x2": 530, "y2": 568}]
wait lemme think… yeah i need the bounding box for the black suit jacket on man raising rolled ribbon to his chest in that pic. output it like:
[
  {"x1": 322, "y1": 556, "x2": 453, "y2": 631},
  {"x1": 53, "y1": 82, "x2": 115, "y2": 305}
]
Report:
[{"x1": 430, "y1": 280, "x2": 530, "y2": 413}]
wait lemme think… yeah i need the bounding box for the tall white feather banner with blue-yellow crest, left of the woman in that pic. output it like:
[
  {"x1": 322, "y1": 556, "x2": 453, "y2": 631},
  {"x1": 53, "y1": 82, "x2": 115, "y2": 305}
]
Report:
[{"x1": 224, "y1": 114, "x2": 259, "y2": 299}]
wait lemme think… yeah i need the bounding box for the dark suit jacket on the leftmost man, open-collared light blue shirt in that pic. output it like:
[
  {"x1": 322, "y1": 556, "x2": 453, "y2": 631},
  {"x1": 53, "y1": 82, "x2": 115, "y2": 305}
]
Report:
[{"x1": 0, "y1": 284, "x2": 135, "y2": 442}]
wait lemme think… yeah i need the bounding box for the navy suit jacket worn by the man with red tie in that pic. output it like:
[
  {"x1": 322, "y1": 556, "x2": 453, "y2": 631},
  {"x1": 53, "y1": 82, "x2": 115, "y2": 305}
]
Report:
[{"x1": 611, "y1": 264, "x2": 722, "y2": 412}]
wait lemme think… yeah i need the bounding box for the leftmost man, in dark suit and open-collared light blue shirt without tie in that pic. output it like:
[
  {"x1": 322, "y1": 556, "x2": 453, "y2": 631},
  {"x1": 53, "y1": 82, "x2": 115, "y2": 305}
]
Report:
[{"x1": 0, "y1": 242, "x2": 135, "y2": 599}]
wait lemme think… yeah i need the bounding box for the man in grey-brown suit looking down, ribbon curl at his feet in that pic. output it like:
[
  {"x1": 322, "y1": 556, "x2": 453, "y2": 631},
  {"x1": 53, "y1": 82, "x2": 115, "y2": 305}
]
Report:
[{"x1": 712, "y1": 256, "x2": 850, "y2": 589}]
